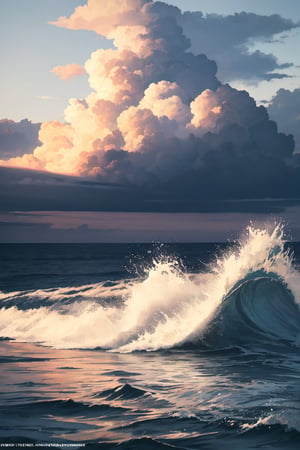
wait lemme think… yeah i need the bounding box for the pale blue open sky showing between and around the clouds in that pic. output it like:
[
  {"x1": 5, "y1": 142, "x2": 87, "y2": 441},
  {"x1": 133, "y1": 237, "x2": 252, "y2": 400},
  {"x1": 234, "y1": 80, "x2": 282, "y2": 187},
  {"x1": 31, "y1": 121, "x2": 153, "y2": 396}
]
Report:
[{"x1": 0, "y1": 0, "x2": 300, "y2": 122}]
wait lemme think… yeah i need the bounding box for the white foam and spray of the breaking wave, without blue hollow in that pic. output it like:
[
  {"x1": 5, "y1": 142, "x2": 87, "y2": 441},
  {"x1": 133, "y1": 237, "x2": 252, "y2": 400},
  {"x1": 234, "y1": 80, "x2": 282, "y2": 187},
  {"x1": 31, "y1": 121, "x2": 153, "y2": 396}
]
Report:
[{"x1": 0, "y1": 225, "x2": 300, "y2": 352}]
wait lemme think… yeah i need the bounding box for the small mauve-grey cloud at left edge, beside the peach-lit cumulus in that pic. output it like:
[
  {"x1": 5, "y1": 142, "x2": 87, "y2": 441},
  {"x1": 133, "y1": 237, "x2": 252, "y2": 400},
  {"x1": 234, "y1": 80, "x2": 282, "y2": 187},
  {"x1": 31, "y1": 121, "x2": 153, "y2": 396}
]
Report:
[{"x1": 0, "y1": 119, "x2": 40, "y2": 160}]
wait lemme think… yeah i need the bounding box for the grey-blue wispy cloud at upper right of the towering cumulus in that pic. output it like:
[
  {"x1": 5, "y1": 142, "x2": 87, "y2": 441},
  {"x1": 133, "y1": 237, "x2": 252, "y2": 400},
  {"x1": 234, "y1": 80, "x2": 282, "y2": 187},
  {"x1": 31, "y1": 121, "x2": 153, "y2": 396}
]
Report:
[{"x1": 178, "y1": 12, "x2": 300, "y2": 82}]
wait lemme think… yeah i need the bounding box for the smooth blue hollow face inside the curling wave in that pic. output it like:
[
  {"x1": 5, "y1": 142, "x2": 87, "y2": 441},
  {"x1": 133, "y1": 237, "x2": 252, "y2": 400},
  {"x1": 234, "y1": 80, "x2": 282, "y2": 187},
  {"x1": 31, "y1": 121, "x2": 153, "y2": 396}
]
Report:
[{"x1": 206, "y1": 271, "x2": 300, "y2": 346}]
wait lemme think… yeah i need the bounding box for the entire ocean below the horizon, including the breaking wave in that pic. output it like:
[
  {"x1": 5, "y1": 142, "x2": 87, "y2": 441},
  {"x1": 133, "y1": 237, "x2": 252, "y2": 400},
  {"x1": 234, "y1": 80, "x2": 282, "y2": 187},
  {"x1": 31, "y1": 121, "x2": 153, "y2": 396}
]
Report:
[{"x1": 0, "y1": 226, "x2": 300, "y2": 450}]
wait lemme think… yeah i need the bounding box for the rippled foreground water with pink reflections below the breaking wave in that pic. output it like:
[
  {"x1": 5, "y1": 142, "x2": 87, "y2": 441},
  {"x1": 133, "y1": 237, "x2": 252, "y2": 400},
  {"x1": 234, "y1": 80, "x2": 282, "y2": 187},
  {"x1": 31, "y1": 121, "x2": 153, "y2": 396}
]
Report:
[{"x1": 0, "y1": 341, "x2": 300, "y2": 448}]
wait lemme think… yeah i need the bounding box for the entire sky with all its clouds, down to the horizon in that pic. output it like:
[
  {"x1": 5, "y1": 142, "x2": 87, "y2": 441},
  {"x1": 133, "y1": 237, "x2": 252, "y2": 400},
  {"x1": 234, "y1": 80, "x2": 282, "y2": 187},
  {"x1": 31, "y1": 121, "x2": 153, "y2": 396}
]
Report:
[{"x1": 0, "y1": 0, "x2": 300, "y2": 242}]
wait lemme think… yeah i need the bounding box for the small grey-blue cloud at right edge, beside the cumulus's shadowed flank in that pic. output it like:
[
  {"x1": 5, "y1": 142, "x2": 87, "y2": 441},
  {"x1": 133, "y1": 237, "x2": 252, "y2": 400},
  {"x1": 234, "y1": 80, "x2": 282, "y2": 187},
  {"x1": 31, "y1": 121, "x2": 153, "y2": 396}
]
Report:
[{"x1": 268, "y1": 88, "x2": 300, "y2": 152}]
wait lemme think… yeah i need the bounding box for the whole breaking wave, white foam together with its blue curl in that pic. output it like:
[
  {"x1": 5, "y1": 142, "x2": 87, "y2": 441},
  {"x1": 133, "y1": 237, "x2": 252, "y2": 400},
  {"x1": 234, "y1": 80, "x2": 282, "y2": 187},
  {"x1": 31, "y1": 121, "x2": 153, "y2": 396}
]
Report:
[{"x1": 0, "y1": 225, "x2": 300, "y2": 352}]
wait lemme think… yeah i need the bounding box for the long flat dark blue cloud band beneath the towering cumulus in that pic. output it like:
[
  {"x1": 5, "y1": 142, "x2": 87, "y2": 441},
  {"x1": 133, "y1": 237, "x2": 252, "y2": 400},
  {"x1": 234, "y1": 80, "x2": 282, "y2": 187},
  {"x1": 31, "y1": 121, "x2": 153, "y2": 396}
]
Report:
[{"x1": 0, "y1": 167, "x2": 300, "y2": 216}]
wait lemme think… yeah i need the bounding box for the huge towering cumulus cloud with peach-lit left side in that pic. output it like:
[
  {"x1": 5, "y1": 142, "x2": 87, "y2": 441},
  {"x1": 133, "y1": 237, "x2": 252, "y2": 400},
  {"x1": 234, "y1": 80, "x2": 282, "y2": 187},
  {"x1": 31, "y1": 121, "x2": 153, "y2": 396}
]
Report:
[{"x1": 1, "y1": 0, "x2": 296, "y2": 196}]
